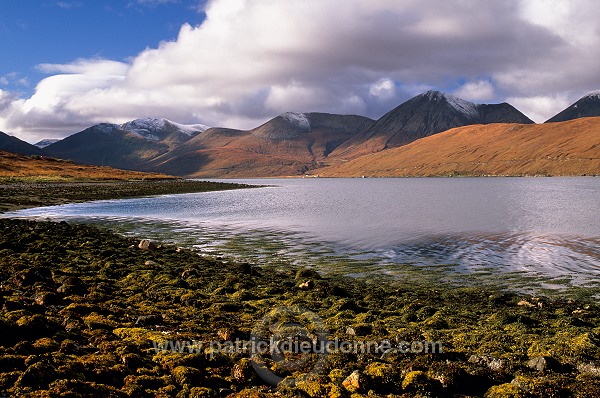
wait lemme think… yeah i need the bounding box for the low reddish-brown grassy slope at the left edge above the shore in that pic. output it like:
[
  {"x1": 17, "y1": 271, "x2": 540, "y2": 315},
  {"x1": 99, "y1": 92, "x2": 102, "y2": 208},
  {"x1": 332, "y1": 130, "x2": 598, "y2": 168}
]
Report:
[{"x1": 0, "y1": 151, "x2": 175, "y2": 181}]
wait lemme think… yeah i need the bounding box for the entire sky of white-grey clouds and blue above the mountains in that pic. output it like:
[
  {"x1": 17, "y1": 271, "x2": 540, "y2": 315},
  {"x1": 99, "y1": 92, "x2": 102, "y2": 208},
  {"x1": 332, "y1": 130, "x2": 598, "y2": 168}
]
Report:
[{"x1": 0, "y1": 0, "x2": 600, "y2": 143}]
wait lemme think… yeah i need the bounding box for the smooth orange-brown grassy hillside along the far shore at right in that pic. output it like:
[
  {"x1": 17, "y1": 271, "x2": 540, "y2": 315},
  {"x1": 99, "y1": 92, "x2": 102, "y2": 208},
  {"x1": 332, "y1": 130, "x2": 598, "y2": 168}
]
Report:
[{"x1": 312, "y1": 117, "x2": 600, "y2": 177}]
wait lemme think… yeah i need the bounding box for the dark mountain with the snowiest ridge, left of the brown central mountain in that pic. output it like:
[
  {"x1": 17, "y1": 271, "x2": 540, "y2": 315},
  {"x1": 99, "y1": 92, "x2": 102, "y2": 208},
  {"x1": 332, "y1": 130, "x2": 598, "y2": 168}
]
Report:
[{"x1": 45, "y1": 118, "x2": 206, "y2": 170}]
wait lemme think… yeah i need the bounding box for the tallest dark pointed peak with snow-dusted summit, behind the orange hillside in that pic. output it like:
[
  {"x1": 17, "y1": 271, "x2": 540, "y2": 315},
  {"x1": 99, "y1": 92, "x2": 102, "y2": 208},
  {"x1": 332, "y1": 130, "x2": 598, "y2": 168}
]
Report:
[{"x1": 332, "y1": 91, "x2": 533, "y2": 158}]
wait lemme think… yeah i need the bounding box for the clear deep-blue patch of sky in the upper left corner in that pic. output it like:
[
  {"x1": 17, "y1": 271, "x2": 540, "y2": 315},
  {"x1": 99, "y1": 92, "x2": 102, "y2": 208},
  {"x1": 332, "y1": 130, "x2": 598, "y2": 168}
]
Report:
[{"x1": 0, "y1": 0, "x2": 204, "y2": 94}]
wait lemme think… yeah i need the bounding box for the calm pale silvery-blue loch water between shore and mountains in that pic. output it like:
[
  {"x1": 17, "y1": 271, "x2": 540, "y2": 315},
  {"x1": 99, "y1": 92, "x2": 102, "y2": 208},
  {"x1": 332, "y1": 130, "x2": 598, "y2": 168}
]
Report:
[{"x1": 7, "y1": 177, "x2": 600, "y2": 290}]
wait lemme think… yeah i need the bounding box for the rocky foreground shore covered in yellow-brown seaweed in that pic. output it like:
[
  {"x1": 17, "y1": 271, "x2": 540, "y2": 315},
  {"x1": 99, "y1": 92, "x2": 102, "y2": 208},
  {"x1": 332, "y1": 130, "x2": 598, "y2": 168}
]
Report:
[{"x1": 0, "y1": 219, "x2": 600, "y2": 397}]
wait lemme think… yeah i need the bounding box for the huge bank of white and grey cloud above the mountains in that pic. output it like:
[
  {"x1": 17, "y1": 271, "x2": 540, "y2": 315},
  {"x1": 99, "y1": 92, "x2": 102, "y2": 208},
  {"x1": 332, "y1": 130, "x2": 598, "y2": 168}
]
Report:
[{"x1": 0, "y1": 0, "x2": 600, "y2": 138}]
